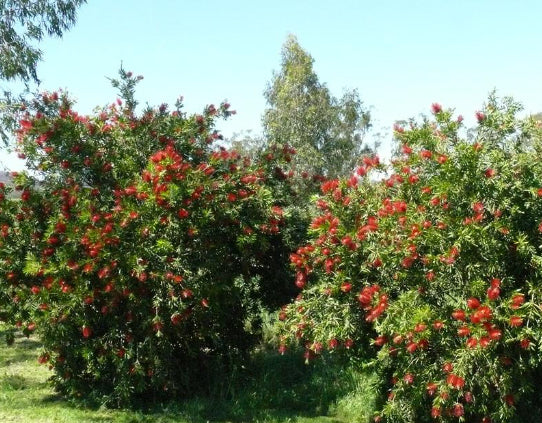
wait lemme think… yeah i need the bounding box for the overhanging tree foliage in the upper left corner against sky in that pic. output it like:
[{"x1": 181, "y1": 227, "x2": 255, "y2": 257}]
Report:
[{"x1": 0, "y1": 0, "x2": 86, "y2": 144}]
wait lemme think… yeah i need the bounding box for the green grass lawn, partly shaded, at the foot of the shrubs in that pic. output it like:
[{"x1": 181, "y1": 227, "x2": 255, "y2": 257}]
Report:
[{"x1": 0, "y1": 325, "x2": 375, "y2": 423}]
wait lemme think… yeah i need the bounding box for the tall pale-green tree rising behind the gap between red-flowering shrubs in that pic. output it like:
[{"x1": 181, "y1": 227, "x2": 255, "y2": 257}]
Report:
[{"x1": 263, "y1": 35, "x2": 370, "y2": 177}]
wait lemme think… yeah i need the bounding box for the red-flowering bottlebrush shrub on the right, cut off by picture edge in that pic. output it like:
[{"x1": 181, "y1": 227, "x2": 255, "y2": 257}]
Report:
[{"x1": 278, "y1": 96, "x2": 542, "y2": 422}]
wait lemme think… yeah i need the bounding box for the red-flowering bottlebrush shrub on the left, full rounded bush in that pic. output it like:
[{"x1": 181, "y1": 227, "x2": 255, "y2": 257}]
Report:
[{"x1": 0, "y1": 71, "x2": 306, "y2": 404}]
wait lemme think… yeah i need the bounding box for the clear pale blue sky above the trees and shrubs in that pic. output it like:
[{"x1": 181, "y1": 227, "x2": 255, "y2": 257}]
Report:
[{"x1": 0, "y1": 0, "x2": 542, "y2": 171}]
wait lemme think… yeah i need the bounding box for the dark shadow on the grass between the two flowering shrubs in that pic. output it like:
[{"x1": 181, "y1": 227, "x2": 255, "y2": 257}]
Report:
[{"x1": 41, "y1": 352, "x2": 372, "y2": 423}]
